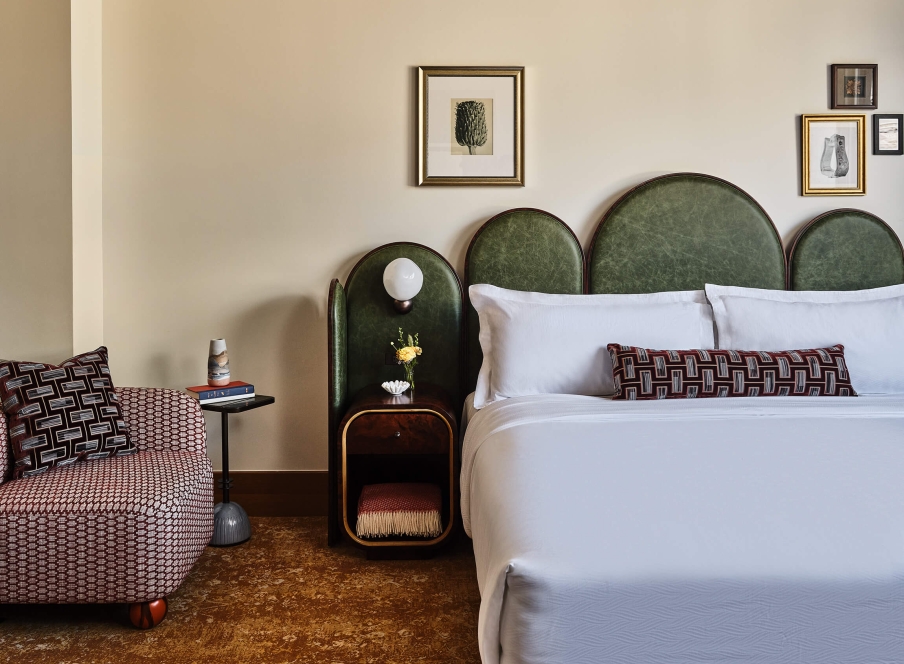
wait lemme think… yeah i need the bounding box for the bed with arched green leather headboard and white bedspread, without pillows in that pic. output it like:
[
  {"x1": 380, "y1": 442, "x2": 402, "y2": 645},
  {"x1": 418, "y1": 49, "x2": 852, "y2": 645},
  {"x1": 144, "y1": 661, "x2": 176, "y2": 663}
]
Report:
[{"x1": 329, "y1": 173, "x2": 904, "y2": 664}]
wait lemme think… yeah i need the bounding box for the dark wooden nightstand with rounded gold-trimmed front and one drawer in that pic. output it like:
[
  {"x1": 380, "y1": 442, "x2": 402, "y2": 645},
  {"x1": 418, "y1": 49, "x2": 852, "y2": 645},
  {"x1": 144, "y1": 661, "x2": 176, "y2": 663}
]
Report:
[{"x1": 336, "y1": 384, "x2": 459, "y2": 558}]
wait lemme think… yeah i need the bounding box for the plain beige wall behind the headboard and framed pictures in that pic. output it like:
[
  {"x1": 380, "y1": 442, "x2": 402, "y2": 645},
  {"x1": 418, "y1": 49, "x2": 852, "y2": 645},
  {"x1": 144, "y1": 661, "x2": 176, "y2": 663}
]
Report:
[{"x1": 103, "y1": 0, "x2": 904, "y2": 469}]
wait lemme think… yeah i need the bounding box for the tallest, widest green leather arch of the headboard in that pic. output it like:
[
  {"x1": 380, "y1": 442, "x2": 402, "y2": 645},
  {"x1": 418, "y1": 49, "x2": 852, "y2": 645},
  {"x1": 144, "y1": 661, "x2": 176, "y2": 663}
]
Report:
[{"x1": 588, "y1": 173, "x2": 785, "y2": 293}]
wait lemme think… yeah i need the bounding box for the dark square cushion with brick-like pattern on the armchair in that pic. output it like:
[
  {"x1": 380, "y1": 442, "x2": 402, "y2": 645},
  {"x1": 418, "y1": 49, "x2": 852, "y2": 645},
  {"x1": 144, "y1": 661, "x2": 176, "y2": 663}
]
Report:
[{"x1": 0, "y1": 346, "x2": 137, "y2": 478}]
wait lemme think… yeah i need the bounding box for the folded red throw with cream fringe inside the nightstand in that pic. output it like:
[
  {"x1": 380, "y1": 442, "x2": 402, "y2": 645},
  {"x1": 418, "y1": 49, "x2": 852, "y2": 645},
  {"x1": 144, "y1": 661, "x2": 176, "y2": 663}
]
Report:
[{"x1": 355, "y1": 484, "x2": 443, "y2": 537}]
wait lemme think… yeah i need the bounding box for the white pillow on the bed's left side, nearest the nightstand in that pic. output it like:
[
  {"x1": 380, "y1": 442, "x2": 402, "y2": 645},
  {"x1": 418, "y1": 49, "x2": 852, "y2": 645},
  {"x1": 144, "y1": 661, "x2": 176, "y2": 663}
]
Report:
[{"x1": 468, "y1": 284, "x2": 714, "y2": 408}]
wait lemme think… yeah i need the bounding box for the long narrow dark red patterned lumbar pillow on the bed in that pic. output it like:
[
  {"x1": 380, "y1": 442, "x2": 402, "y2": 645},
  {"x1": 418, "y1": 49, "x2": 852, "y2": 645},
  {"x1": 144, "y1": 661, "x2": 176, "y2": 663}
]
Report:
[{"x1": 607, "y1": 344, "x2": 857, "y2": 401}]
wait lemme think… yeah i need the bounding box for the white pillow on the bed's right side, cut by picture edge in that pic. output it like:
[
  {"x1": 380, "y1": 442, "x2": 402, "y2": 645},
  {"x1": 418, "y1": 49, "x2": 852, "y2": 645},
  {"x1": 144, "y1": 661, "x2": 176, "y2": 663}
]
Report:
[{"x1": 706, "y1": 284, "x2": 904, "y2": 394}]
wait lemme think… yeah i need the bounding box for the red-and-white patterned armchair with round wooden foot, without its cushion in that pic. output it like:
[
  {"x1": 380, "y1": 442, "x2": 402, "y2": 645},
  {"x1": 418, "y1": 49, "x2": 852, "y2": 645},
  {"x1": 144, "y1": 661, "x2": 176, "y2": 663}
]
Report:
[{"x1": 0, "y1": 388, "x2": 213, "y2": 628}]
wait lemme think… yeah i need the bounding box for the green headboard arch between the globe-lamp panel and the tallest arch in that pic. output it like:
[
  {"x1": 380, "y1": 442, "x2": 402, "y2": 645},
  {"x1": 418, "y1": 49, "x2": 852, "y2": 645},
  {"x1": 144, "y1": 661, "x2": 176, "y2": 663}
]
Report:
[{"x1": 465, "y1": 208, "x2": 584, "y2": 393}]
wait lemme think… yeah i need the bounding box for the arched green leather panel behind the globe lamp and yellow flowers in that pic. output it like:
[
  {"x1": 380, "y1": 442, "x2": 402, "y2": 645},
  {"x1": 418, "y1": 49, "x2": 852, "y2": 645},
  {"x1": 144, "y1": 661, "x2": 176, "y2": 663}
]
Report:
[{"x1": 345, "y1": 242, "x2": 463, "y2": 404}]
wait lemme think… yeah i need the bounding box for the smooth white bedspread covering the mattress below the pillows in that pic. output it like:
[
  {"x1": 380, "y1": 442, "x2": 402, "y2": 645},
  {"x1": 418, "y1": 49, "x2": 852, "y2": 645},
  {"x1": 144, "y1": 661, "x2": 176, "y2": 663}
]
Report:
[{"x1": 461, "y1": 395, "x2": 904, "y2": 664}]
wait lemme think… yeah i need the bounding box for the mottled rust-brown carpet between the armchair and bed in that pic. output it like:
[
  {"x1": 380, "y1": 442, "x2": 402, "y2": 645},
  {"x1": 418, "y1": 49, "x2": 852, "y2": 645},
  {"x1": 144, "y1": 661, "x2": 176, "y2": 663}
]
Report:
[{"x1": 0, "y1": 517, "x2": 480, "y2": 664}]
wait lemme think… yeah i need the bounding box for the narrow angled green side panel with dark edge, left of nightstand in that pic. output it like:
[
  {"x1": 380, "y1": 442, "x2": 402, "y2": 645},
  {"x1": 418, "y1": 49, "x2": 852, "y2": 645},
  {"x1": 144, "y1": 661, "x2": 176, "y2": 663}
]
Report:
[{"x1": 327, "y1": 279, "x2": 348, "y2": 546}]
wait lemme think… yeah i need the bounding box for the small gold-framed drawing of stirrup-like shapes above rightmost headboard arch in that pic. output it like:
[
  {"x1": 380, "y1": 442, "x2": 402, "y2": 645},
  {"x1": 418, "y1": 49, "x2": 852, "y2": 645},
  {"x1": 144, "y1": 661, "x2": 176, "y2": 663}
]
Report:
[{"x1": 800, "y1": 114, "x2": 866, "y2": 196}]
